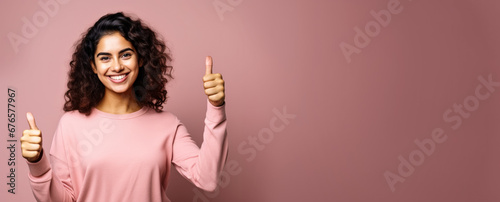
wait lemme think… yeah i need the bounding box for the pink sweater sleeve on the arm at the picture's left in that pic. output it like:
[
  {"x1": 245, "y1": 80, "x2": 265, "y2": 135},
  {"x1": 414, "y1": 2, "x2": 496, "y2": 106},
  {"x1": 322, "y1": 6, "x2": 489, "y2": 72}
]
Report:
[{"x1": 27, "y1": 117, "x2": 76, "y2": 202}]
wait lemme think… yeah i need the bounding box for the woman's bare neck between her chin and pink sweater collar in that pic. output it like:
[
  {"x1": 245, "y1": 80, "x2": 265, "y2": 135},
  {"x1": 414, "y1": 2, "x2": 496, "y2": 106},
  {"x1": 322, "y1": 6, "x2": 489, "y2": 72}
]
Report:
[{"x1": 96, "y1": 89, "x2": 141, "y2": 114}]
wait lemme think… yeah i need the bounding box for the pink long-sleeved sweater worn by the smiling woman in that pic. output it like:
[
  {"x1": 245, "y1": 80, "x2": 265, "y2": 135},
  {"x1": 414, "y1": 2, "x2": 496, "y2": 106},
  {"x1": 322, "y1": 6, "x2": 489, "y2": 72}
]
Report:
[{"x1": 28, "y1": 100, "x2": 228, "y2": 202}]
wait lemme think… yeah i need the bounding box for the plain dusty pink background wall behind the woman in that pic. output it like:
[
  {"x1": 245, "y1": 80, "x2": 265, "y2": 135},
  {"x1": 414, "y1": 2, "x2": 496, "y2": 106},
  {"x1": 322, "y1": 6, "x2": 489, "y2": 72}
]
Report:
[{"x1": 0, "y1": 0, "x2": 500, "y2": 202}]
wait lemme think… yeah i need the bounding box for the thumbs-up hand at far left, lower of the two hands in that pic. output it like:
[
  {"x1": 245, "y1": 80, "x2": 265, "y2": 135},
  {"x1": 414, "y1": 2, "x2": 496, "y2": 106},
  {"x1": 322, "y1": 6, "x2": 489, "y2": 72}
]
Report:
[{"x1": 21, "y1": 112, "x2": 42, "y2": 162}]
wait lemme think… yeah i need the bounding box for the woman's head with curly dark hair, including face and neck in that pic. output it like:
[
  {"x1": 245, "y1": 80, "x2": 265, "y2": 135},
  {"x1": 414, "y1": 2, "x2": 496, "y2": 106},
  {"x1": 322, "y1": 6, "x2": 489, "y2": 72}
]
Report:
[{"x1": 64, "y1": 13, "x2": 172, "y2": 115}]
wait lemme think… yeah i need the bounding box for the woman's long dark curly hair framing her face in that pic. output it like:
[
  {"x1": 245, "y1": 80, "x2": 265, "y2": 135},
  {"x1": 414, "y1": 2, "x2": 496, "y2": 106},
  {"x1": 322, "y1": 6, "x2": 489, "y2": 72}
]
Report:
[{"x1": 63, "y1": 12, "x2": 173, "y2": 116}]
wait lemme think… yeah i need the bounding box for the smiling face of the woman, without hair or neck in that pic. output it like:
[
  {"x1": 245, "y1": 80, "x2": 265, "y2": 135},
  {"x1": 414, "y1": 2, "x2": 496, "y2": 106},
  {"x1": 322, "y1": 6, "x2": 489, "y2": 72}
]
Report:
[{"x1": 92, "y1": 32, "x2": 139, "y2": 94}]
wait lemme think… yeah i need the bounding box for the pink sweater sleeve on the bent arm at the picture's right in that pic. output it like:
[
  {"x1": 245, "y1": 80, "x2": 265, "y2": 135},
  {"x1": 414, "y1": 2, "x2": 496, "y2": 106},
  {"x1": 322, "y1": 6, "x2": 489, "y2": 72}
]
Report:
[{"x1": 172, "y1": 99, "x2": 228, "y2": 191}]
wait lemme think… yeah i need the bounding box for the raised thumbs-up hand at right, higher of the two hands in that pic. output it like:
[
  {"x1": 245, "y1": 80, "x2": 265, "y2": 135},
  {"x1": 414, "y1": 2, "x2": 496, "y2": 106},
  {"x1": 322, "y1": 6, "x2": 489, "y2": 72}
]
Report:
[{"x1": 203, "y1": 56, "x2": 226, "y2": 107}]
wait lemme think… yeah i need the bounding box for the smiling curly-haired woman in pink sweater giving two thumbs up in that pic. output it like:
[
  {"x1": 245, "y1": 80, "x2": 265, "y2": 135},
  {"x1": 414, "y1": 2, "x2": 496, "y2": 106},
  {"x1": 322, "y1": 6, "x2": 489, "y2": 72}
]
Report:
[{"x1": 21, "y1": 12, "x2": 228, "y2": 201}]
